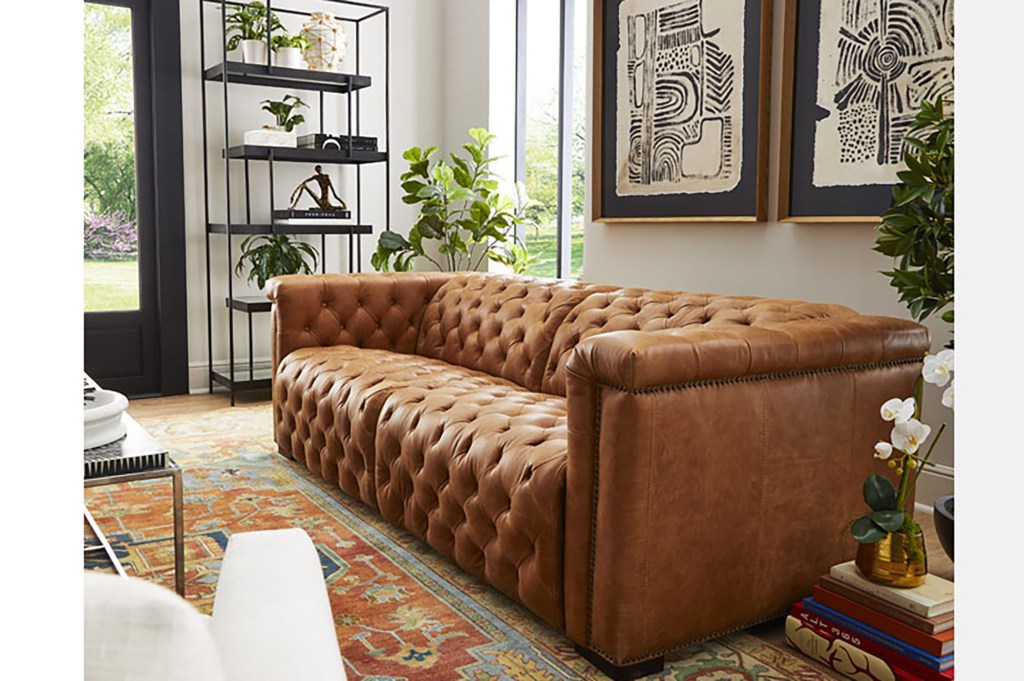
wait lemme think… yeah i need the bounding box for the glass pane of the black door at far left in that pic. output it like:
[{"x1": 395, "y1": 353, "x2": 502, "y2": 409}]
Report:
[{"x1": 83, "y1": 2, "x2": 138, "y2": 312}]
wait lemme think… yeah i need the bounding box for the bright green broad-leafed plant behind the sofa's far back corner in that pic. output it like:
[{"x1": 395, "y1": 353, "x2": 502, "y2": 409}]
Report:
[{"x1": 371, "y1": 128, "x2": 529, "y2": 272}]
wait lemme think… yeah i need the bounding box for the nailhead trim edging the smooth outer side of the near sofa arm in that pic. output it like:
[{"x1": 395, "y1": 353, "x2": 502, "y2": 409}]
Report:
[{"x1": 587, "y1": 357, "x2": 924, "y2": 667}]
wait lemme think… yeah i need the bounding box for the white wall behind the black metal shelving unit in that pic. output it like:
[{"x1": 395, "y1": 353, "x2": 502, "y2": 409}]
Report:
[{"x1": 180, "y1": 0, "x2": 448, "y2": 391}]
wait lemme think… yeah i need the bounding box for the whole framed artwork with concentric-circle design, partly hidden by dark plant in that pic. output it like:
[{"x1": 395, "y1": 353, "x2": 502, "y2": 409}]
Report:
[{"x1": 778, "y1": 0, "x2": 953, "y2": 222}]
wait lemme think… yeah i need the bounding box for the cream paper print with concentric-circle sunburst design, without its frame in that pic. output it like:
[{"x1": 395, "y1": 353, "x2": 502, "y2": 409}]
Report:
[{"x1": 813, "y1": 0, "x2": 953, "y2": 187}]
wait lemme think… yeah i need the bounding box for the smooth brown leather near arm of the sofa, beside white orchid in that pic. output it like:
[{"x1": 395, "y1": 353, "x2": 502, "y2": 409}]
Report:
[{"x1": 564, "y1": 310, "x2": 929, "y2": 666}]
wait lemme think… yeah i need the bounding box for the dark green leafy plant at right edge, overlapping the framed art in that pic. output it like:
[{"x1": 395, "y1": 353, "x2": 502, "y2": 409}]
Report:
[{"x1": 874, "y1": 97, "x2": 953, "y2": 347}]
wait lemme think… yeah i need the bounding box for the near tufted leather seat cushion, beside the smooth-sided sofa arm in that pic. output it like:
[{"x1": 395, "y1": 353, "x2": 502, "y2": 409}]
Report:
[{"x1": 377, "y1": 375, "x2": 568, "y2": 627}]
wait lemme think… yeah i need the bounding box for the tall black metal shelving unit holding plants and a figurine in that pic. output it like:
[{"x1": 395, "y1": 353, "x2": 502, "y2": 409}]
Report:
[{"x1": 199, "y1": 0, "x2": 391, "y2": 405}]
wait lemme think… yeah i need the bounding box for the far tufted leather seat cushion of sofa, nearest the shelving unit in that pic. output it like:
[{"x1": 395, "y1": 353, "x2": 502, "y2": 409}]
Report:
[{"x1": 273, "y1": 345, "x2": 512, "y2": 508}]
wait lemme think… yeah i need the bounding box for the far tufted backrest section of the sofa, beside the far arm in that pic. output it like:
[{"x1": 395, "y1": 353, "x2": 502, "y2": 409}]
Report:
[{"x1": 416, "y1": 273, "x2": 613, "y2": 391}]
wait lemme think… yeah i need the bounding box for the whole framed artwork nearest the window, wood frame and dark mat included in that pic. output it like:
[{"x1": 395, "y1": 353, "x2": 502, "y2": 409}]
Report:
[{"x1": 592, "y1": 0, "x2": 772, "y2": 222}]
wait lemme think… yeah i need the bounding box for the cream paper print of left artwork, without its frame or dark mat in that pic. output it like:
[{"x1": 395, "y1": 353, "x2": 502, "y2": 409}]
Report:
[{"x1": 615, "y1": 0, "x2": 745, "y2": 197}]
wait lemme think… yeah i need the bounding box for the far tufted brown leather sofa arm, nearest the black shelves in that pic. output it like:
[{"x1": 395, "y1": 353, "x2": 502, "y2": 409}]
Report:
[{"x1": 267, "y1": 272, "x2": 453, "y2": 373}]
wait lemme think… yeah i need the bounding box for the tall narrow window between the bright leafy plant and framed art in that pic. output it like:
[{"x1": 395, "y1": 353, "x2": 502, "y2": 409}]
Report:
[{"x1": 516, "y1": 0, "x2": 587, "y2": 279}]
